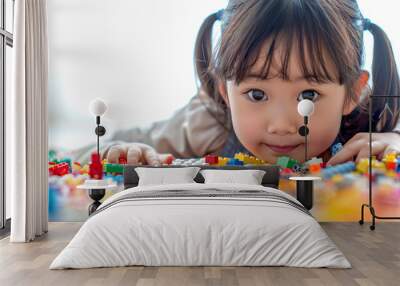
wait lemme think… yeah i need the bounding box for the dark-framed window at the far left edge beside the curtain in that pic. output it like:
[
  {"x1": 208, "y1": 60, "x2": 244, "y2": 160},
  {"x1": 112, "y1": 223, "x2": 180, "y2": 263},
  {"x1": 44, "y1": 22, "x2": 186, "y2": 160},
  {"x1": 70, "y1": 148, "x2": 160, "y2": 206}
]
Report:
[{"x1": 0, "y1": 0, "x2": 14, "y2": 233}]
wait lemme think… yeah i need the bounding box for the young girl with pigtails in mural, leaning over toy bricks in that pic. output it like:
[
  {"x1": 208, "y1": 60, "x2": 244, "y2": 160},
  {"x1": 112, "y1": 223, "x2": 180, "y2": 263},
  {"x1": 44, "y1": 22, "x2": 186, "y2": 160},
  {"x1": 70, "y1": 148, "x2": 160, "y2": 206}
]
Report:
[{"x1": 73, "y1": 0, "x2": 400, "y2": 165}]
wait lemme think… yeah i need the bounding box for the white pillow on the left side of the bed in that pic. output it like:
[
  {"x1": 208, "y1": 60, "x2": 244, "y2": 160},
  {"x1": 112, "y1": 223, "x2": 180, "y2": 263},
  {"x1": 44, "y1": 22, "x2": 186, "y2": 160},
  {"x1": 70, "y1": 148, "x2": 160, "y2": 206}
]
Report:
[{"x1": 135, "y1": 167, "x2": 200, "y2": 186}]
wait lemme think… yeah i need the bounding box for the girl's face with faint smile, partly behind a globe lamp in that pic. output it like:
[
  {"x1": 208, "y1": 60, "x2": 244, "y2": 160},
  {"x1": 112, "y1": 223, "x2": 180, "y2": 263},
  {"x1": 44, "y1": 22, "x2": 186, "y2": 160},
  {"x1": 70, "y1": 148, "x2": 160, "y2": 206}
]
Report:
[{"x1": 220, "y1": 40, "x2": 356, "y2": 163}]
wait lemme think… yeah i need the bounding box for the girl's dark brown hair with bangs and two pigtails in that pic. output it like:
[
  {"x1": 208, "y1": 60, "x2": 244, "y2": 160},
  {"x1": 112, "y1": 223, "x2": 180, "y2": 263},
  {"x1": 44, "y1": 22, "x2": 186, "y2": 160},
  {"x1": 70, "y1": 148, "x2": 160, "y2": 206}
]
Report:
[{"x1": 194, "y1": 0, "x2": 400, "y2": 142}]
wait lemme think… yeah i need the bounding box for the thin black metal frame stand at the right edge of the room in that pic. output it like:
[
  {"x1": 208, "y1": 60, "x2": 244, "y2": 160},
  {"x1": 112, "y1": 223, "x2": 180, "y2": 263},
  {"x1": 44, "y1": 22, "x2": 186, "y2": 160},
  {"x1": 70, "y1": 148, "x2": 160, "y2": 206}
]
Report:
[{"x1": 359, "y1": 95, "x2": 400, "y2": 230}]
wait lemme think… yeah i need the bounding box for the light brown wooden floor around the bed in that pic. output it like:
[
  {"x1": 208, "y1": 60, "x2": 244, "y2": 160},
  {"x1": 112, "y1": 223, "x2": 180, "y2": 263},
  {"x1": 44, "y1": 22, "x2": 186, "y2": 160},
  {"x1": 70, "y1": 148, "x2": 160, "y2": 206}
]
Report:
[{"x1": 0, "y1": 222, "x2": 400, "y2": 286}]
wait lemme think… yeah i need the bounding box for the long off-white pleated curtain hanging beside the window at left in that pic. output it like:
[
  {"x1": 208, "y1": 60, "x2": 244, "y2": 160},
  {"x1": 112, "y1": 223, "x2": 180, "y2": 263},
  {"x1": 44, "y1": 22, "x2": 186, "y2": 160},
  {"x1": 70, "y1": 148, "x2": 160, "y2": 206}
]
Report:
[{"x1": 8, "y1": 0, "x2": 48, "y2": 242}]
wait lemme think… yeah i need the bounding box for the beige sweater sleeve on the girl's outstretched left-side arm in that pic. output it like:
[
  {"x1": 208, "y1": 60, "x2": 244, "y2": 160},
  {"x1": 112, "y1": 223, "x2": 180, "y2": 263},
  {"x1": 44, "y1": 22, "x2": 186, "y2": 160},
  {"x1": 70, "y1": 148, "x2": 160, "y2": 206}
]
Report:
[{"x1": 69, "y1": 92, "x2": 229, "y2": 163}]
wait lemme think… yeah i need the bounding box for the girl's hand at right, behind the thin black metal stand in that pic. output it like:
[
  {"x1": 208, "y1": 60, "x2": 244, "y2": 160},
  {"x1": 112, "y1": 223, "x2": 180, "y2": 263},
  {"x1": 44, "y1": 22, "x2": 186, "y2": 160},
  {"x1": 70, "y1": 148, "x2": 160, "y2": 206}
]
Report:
[{"x1": 327, "y1": 132, "x2": 400, "y2": 166}]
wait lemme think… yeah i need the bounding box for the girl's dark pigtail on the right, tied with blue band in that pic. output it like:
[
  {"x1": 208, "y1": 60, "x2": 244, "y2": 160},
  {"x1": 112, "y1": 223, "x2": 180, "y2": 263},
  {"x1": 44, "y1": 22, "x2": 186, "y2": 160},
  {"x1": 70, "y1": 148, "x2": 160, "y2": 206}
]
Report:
[{"x1": 364, "y1": 19, "x2": 400, "y2": 132}]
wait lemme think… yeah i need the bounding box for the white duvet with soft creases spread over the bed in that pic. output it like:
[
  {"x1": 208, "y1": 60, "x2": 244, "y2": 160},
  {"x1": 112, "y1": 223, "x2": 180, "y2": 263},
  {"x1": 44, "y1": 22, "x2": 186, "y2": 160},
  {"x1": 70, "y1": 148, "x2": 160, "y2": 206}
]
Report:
[{"x1": 50, "y1": 183, "x2": 351, "y2": 269}]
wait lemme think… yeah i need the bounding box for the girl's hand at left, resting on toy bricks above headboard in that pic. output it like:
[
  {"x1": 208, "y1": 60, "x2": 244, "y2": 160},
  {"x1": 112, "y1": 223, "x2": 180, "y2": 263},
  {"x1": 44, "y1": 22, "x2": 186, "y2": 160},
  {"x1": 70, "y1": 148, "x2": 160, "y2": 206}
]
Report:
[{"x1": 105, "y1": 143, "x2": 174, "y2": 165}]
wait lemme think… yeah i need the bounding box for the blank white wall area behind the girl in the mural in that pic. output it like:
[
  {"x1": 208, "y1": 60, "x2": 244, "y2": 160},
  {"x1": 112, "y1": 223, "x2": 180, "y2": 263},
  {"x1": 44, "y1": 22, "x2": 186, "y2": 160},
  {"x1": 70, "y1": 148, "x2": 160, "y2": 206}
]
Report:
[{"x1": 48, "y1": 0, "x2": 400, "y2": 148}]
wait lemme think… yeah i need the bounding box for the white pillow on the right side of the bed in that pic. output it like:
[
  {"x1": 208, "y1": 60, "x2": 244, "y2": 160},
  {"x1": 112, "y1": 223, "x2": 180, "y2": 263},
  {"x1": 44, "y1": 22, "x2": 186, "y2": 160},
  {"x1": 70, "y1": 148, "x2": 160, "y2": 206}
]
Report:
[{"x1": 200, "y1": 169, "x2": 265, "y2": 185}]
